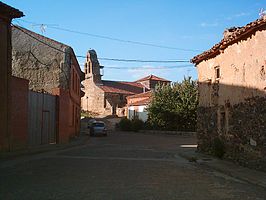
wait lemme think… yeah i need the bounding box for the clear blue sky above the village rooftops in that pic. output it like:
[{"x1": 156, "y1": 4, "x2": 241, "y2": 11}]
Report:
[{"x1": 2, "y1": 0, "x2": 266, "y2": 82}]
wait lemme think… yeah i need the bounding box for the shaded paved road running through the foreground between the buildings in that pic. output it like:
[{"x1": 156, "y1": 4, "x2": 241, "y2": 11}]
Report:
[{"x1": 0, "y1": 133, "x2": 266, "y2": 200}]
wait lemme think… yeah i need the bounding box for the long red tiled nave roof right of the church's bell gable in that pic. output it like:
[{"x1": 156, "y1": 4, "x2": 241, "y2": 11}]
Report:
[{"x1": 98, "y1": 80, "x2": 143, "y2": 95}]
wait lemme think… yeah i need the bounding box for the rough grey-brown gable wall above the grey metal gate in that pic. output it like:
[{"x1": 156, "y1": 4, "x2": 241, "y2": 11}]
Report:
[{"x1": 12, "y1": 28, "x2": 70, "y2": 93}]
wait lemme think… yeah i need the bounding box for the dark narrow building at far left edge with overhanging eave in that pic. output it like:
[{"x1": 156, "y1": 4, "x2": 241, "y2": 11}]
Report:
[{"x1": 0, "y1": 2, "x2": 24, "y2": 151}]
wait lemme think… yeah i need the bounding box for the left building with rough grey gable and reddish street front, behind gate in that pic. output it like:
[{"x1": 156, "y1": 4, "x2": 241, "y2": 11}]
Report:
[{"x1": 12, "y1": 26, "x2": 84, "y2": 142}]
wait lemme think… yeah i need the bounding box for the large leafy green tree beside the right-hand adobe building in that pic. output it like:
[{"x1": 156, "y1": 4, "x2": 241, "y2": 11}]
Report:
[{"x1": 148, "y1": 77, "x2": 198, "y2": 131}]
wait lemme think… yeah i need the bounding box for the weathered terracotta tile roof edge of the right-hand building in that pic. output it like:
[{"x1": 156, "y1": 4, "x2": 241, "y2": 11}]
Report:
[{"x1": 191, "y1": 16, "x2": 266, "y2": 64}]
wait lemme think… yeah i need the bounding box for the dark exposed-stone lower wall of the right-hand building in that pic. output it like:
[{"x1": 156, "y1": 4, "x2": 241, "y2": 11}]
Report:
[{"x1": 197, "y1": 97, "x2": 266, "y2": 168}]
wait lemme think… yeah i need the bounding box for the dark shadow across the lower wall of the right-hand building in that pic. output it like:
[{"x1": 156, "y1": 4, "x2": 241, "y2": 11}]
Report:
[{"x1": 197, "y1": 82, "x2": 266, "y2": 168}]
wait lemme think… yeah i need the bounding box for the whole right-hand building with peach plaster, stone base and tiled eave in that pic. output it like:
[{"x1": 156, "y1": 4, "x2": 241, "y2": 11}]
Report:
[{"x1": 191, "y1": 16, "x2": 266, "y2": 166}]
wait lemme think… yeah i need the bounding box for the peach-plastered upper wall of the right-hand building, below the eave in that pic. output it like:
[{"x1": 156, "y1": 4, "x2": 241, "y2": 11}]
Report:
[{"x1": 197, "y1": 27, "x2": 266, "y2": 106}]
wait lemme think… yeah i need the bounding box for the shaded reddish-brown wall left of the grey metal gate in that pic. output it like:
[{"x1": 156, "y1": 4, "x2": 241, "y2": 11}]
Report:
[{"x1": 10, "y1": 76, "x2": 29, "y2": 151}]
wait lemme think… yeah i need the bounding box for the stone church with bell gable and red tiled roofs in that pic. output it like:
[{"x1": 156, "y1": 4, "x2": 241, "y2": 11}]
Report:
[{"x1": 81, "y1": 50, "x2": 170, "y2": 116}]
